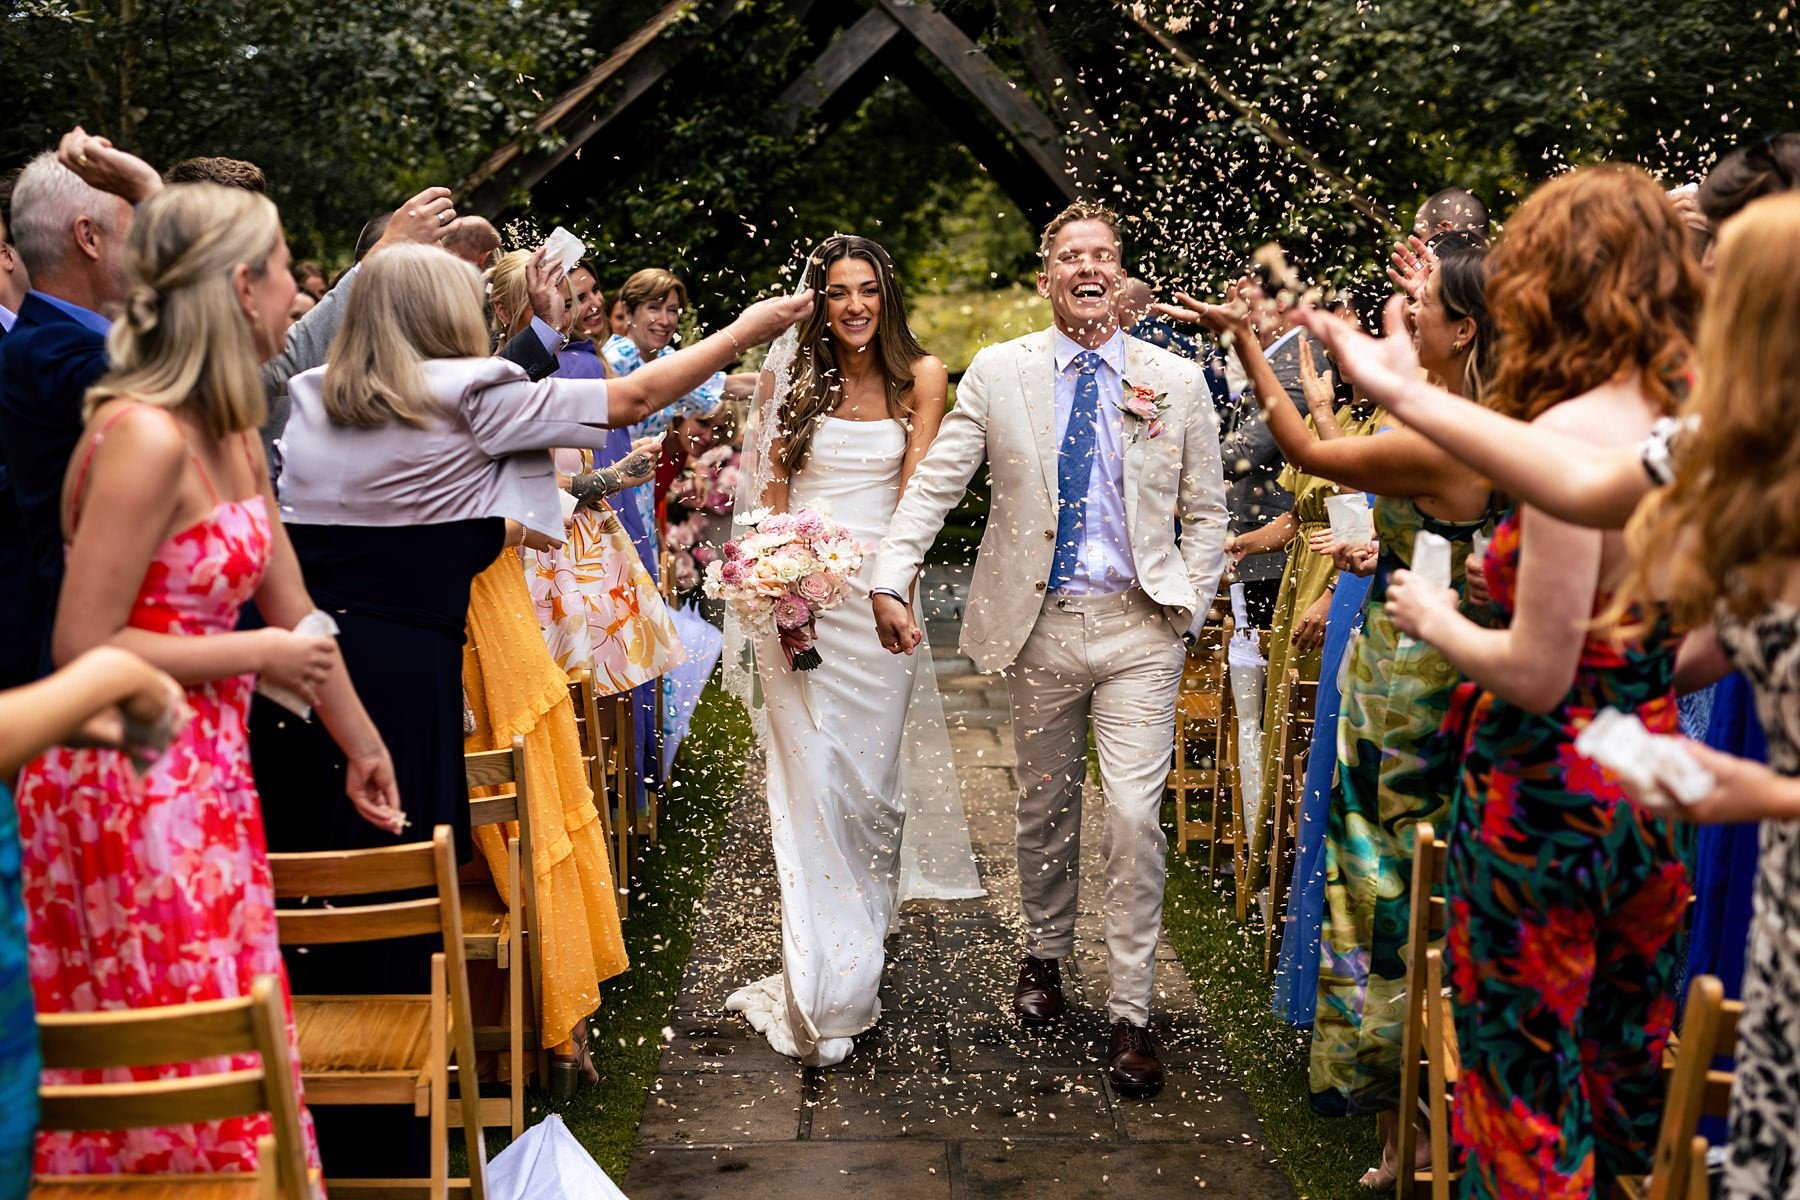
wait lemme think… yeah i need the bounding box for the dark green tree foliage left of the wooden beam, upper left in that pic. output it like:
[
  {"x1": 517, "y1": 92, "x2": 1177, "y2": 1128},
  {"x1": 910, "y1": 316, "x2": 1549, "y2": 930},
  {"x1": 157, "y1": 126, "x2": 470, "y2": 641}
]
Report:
[{"x1": 0, "y1": 0, "x2": 596, "y2": 259}]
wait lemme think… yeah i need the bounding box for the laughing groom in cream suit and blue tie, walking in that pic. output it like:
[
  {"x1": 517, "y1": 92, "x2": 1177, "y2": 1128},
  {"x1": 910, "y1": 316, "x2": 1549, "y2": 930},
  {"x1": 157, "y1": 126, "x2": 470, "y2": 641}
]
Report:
[{"x1": 871, "y1": 203, "x2": 1226, "y2": 1096}]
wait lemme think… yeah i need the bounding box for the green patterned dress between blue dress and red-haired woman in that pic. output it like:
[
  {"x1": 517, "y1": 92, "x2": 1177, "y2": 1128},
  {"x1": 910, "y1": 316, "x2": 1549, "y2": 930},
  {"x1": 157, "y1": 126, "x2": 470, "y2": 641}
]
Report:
[{"x1": 1309, "y1": 497, "x2": 1487, "y2": 1115}]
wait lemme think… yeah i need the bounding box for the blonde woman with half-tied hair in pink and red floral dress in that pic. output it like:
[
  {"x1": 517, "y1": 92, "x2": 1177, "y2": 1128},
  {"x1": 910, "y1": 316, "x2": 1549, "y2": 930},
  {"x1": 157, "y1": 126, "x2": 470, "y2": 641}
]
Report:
[{"x1": 18, "y1": 184, "x2": 400, "y2": 1175}]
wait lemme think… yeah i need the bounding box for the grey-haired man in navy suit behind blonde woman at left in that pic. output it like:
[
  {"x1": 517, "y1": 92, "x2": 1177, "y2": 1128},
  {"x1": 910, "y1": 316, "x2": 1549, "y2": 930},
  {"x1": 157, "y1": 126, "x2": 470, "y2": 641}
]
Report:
[{"x1": 0, "y1": 153, "x2": 131, "y2": 682}]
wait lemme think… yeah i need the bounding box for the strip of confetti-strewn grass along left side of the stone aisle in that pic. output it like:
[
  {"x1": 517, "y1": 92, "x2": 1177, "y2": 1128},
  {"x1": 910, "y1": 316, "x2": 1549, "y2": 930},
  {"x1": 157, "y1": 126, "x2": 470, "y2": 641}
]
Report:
[{"x1": 527, "y1": 676, "x2": 752, "y2": 1182}]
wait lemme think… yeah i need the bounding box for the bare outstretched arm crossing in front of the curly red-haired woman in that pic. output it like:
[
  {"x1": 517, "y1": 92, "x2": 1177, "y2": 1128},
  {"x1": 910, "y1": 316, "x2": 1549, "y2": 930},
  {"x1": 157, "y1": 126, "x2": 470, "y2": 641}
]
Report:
[{"x1": 1296, "y1": 299, "x2": 1652, "y2": 529}]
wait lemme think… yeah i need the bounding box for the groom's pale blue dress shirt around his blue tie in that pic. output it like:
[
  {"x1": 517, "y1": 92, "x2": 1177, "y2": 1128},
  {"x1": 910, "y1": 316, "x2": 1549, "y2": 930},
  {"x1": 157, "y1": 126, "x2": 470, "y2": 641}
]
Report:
[{"x1": 1051, "y1": 329, "x2": 1138, "y2": 596}]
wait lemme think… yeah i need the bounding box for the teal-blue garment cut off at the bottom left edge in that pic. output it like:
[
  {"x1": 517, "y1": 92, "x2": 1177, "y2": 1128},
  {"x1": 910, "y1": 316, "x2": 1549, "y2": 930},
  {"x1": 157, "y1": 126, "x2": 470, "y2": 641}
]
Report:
[{"x1": 0, "y1": 783, "x2": 38, "y2": 1200}]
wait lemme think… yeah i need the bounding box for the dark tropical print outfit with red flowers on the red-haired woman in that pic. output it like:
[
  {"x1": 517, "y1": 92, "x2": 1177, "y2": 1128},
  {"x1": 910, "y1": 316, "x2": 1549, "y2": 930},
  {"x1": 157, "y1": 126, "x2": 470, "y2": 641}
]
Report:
[{"x1": 1445, "y1": 515, "x2": 1688, "y2": 1200}]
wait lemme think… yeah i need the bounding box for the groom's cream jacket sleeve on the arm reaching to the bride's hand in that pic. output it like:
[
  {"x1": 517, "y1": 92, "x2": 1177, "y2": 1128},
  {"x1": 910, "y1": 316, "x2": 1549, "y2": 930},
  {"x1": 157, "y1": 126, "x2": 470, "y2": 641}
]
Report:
[{"x1": 869, "y1": 351, "x2": 992, "y2": 596}]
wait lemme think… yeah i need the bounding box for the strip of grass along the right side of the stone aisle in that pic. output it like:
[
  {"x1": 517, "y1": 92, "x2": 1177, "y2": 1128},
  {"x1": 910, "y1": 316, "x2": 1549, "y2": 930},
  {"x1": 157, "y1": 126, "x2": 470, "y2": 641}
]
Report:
[{"x1": 1163, "y1": 853, "x2": 1381, "y2": 1200}]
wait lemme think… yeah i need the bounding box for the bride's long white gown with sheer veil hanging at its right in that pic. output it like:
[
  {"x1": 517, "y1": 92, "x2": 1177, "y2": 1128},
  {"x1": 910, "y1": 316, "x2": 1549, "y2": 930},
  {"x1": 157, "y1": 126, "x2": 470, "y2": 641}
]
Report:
[{"x1": 725, "y1": 417, "x2": 983, "y2": 1067}]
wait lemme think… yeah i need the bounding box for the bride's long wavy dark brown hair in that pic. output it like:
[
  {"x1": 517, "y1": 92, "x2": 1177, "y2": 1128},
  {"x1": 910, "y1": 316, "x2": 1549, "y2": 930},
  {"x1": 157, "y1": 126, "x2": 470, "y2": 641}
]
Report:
[{"x1": 778, "y1": 234, "x2": 925, "y2": 477}]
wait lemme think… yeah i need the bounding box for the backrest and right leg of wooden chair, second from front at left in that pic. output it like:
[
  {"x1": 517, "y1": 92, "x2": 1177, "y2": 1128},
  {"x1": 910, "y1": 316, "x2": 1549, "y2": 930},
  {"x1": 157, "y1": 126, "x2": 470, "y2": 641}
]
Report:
[{"x1": 268, "y1": 827, "x2": 489, "y2": 1200}]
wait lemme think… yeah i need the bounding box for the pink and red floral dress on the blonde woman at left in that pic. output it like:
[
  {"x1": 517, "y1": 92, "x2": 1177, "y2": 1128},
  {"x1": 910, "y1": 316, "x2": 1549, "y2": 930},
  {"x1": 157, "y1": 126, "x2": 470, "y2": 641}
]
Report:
[{"x1": 18, "y1": 430, "x2": 318, "y2": 1175}]
